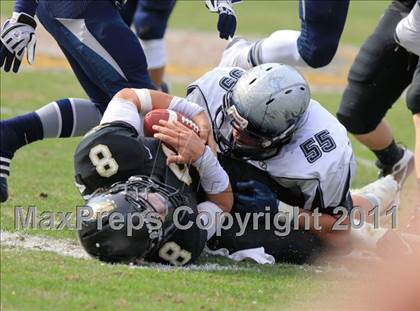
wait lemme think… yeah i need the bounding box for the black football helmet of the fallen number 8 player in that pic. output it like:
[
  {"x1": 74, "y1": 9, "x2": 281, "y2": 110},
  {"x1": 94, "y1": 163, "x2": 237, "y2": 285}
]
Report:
[{"x1": 77, "y1": 176, "x2": 189, "y2": 263}]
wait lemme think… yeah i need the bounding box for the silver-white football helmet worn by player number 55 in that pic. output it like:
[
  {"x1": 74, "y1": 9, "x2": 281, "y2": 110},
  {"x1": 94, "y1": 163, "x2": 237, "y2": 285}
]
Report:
[{"x1": 215, "y1": 63, "x2": 311, "y2": 160}]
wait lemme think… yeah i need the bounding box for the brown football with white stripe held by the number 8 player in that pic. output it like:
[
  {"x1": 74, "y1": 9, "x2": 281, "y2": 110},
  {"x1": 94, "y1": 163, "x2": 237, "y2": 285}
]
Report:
[{"x1": 144, "y1": 109, "x2": 200, "y2": 137}]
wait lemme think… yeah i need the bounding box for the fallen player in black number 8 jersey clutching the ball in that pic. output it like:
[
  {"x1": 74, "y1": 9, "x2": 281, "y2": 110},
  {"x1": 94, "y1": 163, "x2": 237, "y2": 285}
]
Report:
[{"x1": 74, "y1": 89, "x2": 233, "y2": 265}]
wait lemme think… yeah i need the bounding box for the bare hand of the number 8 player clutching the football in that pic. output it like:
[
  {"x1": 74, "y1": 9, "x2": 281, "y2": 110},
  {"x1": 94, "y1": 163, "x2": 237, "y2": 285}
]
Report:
[{"x1": 153, "y1": 120, "x2": 205, "y2": 164}]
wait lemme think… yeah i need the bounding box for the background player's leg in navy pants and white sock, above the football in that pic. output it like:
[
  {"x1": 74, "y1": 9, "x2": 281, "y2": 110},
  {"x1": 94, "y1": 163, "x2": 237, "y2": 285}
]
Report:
[{"x1": 134, "y1": 0, "x2": 175, "y2": 86}]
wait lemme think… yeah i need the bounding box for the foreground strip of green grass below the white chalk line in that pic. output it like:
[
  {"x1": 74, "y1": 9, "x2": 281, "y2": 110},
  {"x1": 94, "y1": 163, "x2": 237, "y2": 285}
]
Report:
[{"x1": 1, "y1": 248, "x2": 335, "y2": 310}]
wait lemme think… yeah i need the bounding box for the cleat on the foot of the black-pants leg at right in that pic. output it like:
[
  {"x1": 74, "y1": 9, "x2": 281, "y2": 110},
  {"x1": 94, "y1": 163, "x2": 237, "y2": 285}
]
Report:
[{"x1": 376, "y1": 147, "x2": 414, "y2": 188}]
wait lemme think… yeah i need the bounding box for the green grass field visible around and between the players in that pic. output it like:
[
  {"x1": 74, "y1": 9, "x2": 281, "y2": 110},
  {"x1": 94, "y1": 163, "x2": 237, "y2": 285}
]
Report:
[{"x1": 0, "y1": 1, "x2": 414, "y2": 310}]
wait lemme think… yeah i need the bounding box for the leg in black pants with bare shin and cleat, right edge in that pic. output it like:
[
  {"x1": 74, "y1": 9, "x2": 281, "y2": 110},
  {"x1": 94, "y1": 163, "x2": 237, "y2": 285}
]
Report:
[{"x1": 337, "y1": 3, "x2": 417, "y2": 185}]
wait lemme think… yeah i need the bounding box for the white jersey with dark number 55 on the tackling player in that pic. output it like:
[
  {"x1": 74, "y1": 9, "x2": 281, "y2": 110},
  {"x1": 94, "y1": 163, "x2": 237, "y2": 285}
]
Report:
[{"x1": 187, "y1": 67, "x2": 355, "y2": 212}]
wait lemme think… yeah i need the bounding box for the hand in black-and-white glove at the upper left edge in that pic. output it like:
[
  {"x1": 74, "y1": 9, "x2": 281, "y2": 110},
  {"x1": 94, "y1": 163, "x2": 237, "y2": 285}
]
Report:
[{"x1": 0, "y1": 13, "x2": 36, "y2": 72}]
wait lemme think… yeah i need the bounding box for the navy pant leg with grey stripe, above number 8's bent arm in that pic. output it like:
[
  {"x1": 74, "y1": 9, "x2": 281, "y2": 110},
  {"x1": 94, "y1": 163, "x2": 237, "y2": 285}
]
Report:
[{"x1": 37, "y1": 0, "x2": 154, "y2": 97}]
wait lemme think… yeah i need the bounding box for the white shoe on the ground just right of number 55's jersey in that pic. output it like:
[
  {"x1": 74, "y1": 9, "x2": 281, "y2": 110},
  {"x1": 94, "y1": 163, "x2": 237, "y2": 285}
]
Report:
[{"x1": 352, "y1": 175, "x2": 399, "y2": 216}]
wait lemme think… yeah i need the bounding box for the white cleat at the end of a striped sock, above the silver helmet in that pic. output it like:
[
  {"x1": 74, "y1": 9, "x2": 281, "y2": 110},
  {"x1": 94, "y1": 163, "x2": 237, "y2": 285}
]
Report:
[{"x1": 219, "y1": 37, "x2": 254, "y2": 69}]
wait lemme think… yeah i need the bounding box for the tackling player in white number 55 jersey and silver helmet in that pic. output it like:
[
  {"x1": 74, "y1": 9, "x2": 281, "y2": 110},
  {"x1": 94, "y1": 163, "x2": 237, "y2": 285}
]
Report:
[{"x1": 162, "y1": 63, "x2": 410, "y2": 254}]
